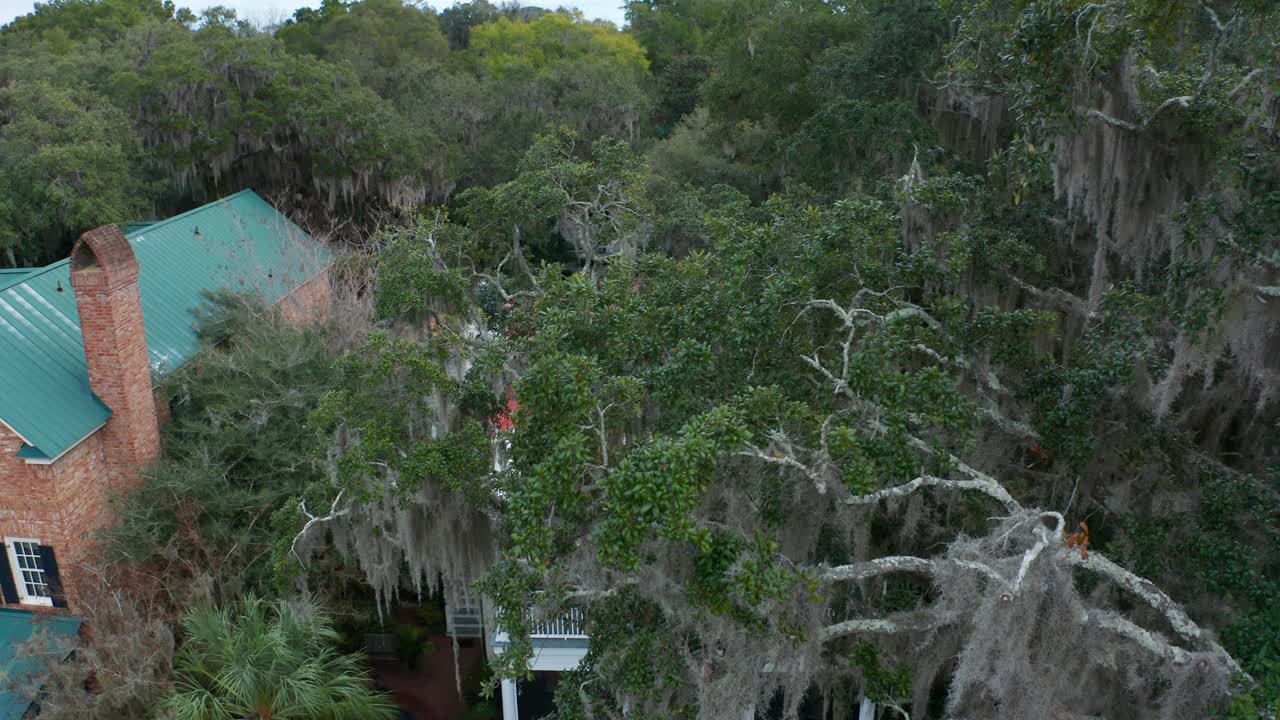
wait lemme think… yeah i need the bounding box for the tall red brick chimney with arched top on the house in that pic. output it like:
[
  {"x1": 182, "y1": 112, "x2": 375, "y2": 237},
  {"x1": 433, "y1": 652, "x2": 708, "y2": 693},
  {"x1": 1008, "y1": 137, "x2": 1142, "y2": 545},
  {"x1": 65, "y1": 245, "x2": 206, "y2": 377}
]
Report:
[{"x1": 72, "y1": 225, "x2": 160, "y2": 487}]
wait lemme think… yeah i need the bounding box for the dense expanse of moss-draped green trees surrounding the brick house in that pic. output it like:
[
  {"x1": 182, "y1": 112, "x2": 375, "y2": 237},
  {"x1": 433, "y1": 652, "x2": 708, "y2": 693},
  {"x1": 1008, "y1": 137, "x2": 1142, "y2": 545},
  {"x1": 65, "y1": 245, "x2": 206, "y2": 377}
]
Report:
[{"x1": 0, "y1": 0, "x2": 1280, "y2": 720}]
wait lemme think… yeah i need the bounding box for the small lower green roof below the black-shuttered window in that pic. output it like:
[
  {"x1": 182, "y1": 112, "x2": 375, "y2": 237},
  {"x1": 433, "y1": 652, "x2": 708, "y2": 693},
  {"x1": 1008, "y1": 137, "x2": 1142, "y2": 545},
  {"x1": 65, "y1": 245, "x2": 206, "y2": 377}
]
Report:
[{"x1": 0, "y1": 610, "x2": 81, "y2": 720}]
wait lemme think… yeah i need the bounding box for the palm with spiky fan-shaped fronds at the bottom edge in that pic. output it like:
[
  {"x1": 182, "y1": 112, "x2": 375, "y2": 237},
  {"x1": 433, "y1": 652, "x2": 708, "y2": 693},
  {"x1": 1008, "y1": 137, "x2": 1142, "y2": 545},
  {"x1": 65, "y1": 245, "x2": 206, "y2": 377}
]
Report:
[{"x1": 164, "y1": 596, "x2": 397, "y2": 720}]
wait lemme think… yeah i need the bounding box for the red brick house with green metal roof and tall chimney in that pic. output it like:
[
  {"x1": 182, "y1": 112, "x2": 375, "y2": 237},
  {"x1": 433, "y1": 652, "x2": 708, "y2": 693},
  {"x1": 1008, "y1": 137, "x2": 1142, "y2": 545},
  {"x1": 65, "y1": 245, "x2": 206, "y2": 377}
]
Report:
[{"x1": 0, "y1": 184, "x2": 332, "y2": 617}]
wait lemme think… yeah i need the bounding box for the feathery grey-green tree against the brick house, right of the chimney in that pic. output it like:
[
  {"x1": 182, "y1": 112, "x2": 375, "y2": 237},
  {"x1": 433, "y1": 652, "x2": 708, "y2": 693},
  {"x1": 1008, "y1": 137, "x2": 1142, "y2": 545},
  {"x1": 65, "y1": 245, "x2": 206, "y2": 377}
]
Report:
[{"x1": 104, "y1": 296, "x2": 335, "y2": 598}]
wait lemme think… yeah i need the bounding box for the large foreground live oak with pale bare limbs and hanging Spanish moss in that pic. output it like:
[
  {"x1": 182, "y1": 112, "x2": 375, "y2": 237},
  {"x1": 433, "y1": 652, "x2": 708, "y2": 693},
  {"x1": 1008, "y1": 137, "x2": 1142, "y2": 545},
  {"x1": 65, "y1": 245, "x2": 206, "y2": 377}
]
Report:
[{"x1": 291, "y1": 126, "x2": 1254, "y2": 717}]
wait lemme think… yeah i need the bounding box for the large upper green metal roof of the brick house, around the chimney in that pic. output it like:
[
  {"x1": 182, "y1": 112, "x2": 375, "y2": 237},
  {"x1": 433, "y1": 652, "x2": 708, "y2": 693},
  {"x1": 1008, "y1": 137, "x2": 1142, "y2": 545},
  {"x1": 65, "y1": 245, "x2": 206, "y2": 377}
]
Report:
[{"x1": 0, "y1": 190, "x2": 332, "y2": 459}]
